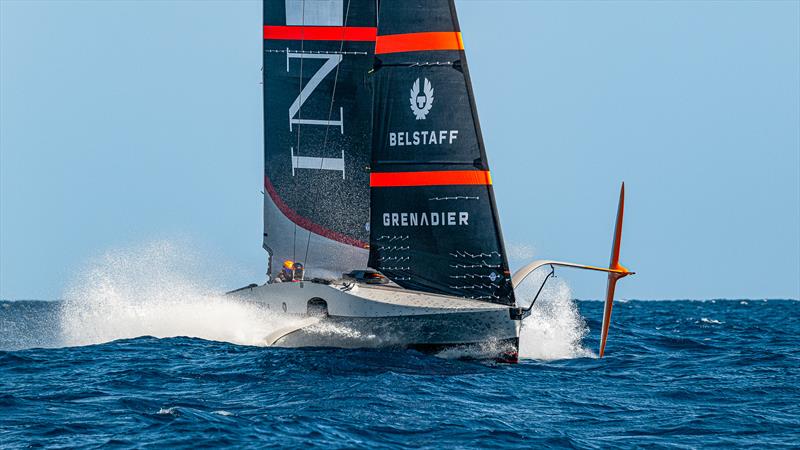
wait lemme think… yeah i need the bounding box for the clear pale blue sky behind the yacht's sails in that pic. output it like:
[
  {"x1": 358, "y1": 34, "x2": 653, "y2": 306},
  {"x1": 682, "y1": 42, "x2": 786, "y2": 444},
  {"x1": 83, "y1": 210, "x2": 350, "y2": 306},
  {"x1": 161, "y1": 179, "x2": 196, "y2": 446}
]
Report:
[{"x1": 0, "y1": 0, "x2": 800, "y2": 299}]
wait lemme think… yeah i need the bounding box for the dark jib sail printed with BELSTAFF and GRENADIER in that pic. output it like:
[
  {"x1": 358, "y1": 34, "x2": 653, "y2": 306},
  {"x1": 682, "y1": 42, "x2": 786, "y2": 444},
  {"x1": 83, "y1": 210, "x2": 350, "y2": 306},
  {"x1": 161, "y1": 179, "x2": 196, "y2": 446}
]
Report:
[{"x1": 369, "y1": 0, "x2": 514, "y2": 305}]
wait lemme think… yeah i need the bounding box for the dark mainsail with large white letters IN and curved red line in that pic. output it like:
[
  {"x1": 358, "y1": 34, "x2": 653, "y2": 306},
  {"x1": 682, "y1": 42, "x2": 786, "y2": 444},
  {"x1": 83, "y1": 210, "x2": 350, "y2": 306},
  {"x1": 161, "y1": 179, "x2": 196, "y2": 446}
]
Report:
[{"x1": 263, "y1": 0, "x2": 377, "y2": 277}]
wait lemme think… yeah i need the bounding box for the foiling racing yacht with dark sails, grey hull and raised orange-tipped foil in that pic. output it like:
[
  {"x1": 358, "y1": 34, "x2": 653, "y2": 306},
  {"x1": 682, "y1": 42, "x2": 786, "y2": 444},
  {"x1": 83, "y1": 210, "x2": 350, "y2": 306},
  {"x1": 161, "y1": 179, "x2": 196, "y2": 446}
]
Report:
[{"x1": 232, "y1": 0, "x2": 631, "y2": 361}]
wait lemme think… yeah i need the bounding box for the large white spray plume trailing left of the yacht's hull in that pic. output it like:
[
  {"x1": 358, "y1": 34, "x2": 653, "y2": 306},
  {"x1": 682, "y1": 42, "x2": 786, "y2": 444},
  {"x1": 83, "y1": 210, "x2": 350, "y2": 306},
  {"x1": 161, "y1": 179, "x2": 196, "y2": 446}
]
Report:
[{"x1": 60, "y1": 241, "x2": 300, "y2": 346}]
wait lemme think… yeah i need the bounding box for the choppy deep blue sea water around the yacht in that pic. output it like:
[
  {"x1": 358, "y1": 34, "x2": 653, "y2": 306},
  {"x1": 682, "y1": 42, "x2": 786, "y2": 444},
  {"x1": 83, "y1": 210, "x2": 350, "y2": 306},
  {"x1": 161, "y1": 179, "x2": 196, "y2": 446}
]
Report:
[{"x1": 0, "y1": 300, "x2": 800, "y2": 448}]
